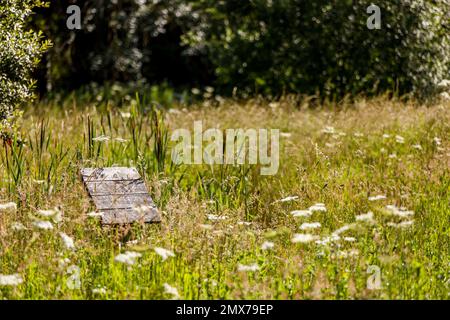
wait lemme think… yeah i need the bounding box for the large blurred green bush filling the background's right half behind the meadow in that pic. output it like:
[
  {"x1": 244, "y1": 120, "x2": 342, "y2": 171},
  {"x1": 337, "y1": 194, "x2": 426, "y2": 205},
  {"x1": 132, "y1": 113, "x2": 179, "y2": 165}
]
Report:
[{"x1": 185, "y1": 0, "x2": 450, "y2": 97}]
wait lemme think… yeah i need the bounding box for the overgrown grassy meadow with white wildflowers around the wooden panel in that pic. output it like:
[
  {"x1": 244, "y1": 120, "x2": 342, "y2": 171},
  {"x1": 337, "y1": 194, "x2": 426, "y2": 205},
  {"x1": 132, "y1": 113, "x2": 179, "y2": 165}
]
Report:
[{"x1": 0, "y1": 98, "x2": 450, "y2": 299}]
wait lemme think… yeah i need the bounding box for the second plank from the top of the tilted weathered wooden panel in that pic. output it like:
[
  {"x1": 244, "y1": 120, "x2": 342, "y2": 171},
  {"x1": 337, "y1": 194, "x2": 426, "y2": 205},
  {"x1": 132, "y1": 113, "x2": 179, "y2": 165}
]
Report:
[{"x1": 85, "y1": 180, "x2": 148, "y2": 196}]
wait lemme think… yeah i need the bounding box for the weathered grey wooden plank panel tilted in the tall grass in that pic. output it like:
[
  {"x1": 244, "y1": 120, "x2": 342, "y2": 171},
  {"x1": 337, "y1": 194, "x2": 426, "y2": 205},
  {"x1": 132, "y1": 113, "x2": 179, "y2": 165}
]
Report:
[{"x1": 81, "y1": 167, "x2": 161, "y2": 224}]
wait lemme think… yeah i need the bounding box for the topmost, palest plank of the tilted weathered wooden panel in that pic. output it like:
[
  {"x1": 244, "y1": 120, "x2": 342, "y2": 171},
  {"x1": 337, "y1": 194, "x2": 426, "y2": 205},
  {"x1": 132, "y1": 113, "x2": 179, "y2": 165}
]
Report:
[{"x1": 81, "y1": 167, "x2": 141, "y2": 181}]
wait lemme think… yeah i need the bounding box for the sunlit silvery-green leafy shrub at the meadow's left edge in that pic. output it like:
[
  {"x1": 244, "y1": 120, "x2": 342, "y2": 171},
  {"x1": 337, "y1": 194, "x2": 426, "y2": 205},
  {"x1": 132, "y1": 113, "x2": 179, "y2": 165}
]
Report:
[{"x1": 0, "y1": 0, "x2": 49, "y2": 139}]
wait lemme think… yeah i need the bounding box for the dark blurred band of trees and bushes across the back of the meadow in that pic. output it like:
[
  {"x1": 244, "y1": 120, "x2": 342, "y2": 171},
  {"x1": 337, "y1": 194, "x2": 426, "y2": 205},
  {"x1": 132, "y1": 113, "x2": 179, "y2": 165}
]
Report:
[{"x1": 31, "y1": 0, "x2": 450, "y2": 97}]
